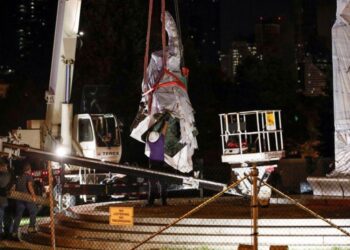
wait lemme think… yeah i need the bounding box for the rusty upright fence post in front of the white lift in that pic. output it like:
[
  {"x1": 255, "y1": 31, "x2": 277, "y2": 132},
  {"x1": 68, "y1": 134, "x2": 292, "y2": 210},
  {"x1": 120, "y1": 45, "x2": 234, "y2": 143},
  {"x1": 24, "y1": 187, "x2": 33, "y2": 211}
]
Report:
[{"x1": 250, "y1": 163, "x2": 259, "y2": 250}]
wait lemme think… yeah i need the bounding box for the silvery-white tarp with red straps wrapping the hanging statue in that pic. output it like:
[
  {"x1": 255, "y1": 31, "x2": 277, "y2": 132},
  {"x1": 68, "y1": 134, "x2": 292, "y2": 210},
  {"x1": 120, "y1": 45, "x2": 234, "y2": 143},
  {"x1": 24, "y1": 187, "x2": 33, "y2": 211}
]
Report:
[{"x1": 130, "y1": 12, "x2": 198, "y2": 173}]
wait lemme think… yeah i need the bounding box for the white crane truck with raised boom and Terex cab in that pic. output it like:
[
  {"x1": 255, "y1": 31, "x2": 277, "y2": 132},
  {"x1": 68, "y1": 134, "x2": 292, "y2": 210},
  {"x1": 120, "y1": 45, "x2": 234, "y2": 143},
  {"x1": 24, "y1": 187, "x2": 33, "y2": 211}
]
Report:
[{"x1": 2, "y1": 0, "x2": 122, "y2": 205}]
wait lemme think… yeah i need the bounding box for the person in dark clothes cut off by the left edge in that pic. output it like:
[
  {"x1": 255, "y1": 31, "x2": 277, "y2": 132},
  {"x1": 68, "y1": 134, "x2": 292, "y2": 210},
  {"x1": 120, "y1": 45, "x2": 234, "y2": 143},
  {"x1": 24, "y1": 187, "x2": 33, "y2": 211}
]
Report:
[{"x1": 0, "y1": 159, "x2": 11, "y2": 240}]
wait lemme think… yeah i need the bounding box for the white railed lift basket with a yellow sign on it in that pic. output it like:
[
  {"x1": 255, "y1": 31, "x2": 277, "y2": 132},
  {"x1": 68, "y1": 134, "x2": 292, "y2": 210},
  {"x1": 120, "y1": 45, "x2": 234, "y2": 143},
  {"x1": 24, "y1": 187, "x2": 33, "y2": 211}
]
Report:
[{"x1": 219, "y1": 110, "x2": 284, "y2": 164}]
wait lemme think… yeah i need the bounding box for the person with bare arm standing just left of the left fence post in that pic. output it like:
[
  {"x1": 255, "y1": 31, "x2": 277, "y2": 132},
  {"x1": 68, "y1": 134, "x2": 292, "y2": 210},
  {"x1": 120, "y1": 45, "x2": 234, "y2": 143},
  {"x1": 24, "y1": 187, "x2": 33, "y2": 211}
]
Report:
[{"x1": 12, "y1": 163, "x2": 38, "y2": 237}]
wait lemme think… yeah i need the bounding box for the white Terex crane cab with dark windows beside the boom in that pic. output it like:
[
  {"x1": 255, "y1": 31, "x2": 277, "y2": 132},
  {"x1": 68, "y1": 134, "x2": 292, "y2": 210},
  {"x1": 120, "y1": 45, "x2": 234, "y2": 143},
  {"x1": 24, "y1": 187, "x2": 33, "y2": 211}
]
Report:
[{"x1": 73, "y1": 114, "x2": 122, "y2": 162}]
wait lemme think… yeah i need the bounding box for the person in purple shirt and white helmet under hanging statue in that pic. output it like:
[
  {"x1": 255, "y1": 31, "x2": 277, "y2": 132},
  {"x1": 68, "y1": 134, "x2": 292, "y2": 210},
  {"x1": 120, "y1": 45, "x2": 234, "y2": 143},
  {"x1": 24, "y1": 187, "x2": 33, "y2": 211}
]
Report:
[{"x1": 147, "y1": 121, "x2": 168, "y2": 206}]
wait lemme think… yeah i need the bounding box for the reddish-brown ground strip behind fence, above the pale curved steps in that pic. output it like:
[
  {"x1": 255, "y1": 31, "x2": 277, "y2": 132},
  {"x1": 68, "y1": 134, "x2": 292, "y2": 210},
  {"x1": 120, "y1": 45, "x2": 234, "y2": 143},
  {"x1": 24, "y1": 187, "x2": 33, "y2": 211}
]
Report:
[{"x1": 95, "y1": 197, "x2": 350, "y2": 219}]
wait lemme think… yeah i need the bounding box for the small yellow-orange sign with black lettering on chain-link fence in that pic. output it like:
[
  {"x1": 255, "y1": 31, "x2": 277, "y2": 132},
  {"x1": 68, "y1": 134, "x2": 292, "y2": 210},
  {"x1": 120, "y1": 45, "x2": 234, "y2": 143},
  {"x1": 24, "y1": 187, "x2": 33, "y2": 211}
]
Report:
[{"x1": 109, "y1": 207, "x2": 134, "y2": 226}]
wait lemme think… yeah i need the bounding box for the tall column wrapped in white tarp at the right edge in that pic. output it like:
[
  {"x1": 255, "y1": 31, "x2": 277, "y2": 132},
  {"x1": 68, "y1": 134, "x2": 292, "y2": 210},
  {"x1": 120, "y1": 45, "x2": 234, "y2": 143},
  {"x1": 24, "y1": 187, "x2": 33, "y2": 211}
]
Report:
[{"x1": 329, "y1": 0, "x2": 350, "y2": 177}]
